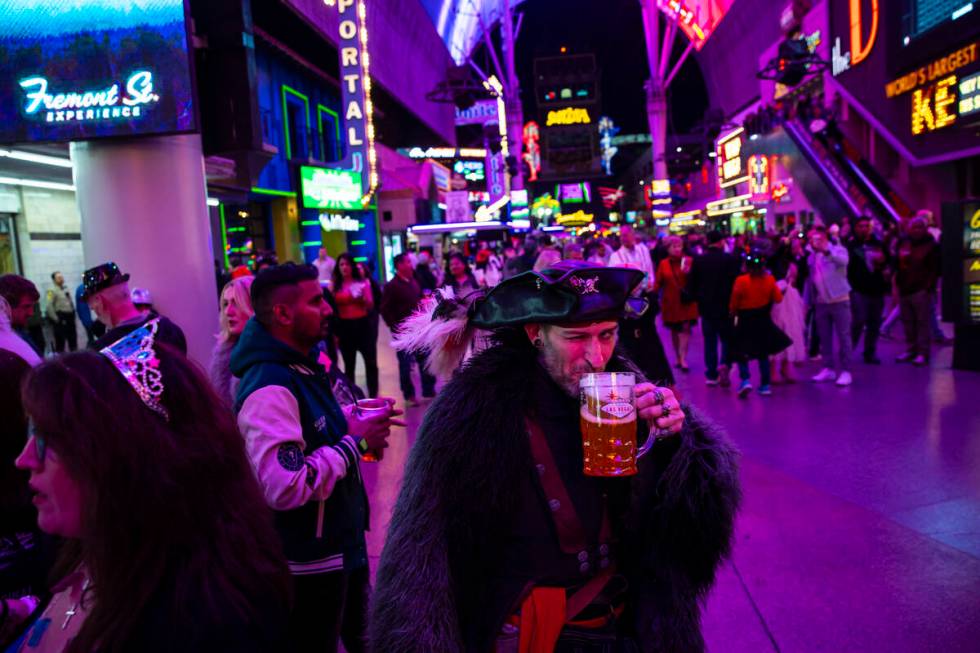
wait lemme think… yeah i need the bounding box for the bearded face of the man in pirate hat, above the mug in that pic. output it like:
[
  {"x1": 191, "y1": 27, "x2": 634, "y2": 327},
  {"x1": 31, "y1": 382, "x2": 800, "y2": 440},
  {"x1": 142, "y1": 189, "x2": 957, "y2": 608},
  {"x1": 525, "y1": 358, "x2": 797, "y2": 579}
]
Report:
[{"x1": 538, "y1": 322, "x2": 619, "y2": 397}]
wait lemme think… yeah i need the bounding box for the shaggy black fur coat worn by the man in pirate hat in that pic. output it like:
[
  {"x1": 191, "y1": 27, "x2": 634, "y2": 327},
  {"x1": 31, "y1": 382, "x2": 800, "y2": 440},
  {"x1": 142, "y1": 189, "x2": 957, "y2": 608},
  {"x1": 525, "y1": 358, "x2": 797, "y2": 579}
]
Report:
[{"x1": 369, "y1": 333, "x2": 740, "y2": 653}]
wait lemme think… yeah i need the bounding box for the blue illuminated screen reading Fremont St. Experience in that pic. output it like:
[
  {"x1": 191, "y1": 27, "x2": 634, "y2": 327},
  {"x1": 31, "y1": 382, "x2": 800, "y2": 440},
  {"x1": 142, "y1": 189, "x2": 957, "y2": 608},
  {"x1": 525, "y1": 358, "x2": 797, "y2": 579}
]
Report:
[{"x1": 0, "y1": 0, "x2": 197, "y2": 143}]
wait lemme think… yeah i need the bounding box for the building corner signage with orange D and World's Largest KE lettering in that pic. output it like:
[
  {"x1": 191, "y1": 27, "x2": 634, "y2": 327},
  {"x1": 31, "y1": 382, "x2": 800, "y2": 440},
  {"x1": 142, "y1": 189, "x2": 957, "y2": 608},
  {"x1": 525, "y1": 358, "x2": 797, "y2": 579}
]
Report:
[{"x1": 828, "y1": 0, "x2": 980, "y2": 165}]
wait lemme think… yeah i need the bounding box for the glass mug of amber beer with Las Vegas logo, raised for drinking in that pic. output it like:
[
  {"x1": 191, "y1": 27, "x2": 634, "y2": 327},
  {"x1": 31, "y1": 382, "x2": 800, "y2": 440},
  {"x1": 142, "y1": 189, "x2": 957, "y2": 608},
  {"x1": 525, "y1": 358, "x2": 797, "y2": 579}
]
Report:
[{"x1": 579, "y1": 372, "x2": 656, "y2": 476}]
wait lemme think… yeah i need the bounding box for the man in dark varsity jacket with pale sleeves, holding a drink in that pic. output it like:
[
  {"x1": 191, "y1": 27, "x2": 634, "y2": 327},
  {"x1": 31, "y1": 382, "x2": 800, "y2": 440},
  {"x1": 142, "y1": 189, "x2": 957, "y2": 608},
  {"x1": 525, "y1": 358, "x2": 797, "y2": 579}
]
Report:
[{"x1": 231, "y1": 263, "x2": 401, "y2": 653}]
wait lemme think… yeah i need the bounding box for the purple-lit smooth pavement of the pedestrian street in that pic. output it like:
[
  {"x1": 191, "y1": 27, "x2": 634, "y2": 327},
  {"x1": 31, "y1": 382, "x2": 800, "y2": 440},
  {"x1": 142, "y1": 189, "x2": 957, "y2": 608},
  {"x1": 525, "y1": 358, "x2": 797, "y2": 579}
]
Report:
[{"x1": 359, "y1": 327, "x2": 980, "y2": 653}]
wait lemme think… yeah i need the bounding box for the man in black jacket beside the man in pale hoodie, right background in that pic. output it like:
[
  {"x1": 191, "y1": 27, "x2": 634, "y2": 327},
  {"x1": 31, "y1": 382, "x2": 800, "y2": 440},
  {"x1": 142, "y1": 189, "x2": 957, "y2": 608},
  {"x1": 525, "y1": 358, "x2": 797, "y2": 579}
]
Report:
[{"x1": 847, "y1": 216, "x2": 891, "y2": 365}]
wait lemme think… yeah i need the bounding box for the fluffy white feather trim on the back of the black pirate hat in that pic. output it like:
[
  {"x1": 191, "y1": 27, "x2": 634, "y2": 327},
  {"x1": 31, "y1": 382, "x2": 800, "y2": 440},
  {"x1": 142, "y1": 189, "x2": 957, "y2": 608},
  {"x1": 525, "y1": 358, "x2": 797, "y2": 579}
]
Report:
[{"x1": 392, "y1": 288, "x2": 483, "y2": 379}]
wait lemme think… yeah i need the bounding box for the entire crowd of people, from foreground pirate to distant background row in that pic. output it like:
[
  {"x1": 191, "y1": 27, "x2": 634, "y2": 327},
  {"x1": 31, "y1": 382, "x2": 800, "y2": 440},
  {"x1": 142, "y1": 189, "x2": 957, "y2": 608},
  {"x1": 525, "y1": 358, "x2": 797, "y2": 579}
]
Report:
[{"x1": 0, "y1": 208, "x2": 939, "y2": 653}]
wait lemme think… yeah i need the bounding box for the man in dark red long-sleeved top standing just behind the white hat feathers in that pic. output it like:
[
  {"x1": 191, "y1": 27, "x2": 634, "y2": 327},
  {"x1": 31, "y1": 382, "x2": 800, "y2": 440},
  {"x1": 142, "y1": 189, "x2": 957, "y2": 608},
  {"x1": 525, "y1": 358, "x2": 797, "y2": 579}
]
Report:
[{"x1": 381, "y1": 253, "x2": 436, "y2": 405}]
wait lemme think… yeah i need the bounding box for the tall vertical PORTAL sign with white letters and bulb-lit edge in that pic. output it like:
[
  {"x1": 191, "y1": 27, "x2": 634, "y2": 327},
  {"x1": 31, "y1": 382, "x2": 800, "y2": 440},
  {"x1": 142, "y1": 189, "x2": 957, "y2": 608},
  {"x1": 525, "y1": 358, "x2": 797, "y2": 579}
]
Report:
[{"x1": 323, "y1": 0, "x2": 378, "y2": 206}]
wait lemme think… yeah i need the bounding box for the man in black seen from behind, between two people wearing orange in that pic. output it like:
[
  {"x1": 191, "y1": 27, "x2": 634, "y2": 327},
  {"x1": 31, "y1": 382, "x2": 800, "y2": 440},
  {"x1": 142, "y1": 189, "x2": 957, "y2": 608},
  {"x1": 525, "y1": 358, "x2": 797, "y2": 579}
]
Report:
[{"x1": 687, "y1": 231, "x2": 740, "y2": 387}]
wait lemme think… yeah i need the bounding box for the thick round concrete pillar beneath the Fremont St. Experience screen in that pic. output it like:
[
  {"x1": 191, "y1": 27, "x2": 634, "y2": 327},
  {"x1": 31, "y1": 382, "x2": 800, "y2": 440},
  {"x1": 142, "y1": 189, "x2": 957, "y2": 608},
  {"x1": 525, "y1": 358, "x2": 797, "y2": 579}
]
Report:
[{"x1": 71, "y1": 134, "x2": 218, "y2": 365}]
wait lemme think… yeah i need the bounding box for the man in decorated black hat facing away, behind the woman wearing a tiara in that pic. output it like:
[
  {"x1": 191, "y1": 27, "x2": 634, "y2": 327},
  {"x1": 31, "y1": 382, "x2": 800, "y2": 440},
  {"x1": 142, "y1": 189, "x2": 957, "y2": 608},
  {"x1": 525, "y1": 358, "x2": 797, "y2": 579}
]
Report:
[{"x1": 82, "y1": 261, "x2": 187, "y2": 355}]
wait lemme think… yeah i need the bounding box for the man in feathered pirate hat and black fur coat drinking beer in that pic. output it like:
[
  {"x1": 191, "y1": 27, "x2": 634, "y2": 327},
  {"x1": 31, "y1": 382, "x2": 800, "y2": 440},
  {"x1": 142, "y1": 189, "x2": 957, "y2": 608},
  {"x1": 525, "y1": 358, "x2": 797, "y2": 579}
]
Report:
[{"x1": 369, "y1": 261, "x2": 740, "y2": 653}]
